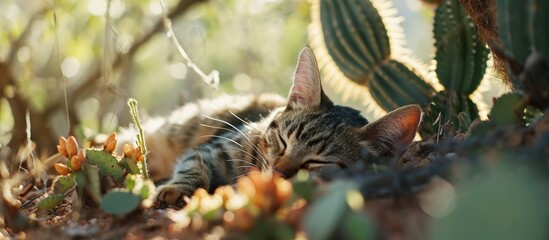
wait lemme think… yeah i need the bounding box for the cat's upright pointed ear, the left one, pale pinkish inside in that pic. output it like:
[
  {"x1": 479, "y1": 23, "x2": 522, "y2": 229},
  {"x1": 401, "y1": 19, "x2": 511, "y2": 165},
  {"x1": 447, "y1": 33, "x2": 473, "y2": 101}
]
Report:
[{"x1": 286, "y1": 47, "x2": 333, "y2": 110}]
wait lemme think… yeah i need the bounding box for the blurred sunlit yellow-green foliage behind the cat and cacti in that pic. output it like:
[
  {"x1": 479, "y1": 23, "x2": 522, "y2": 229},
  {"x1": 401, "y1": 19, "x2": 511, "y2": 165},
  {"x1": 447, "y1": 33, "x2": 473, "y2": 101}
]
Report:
[{"x1": 0, "y1": 0, "x2": 501, "y2": 154}]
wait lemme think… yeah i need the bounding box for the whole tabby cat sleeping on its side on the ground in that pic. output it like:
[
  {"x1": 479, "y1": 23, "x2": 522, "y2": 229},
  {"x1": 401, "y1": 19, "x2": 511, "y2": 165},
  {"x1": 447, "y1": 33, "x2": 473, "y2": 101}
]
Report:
[{"x1": 148, "y1": 48, "x2": 421, "y2": 206}]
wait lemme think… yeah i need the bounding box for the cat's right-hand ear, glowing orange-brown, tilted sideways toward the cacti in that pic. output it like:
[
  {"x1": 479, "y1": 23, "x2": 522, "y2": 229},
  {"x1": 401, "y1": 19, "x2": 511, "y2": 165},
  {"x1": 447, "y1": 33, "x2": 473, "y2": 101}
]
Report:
[{"x1": 360, "y1": 105, "x2": 422, "y2": 157}]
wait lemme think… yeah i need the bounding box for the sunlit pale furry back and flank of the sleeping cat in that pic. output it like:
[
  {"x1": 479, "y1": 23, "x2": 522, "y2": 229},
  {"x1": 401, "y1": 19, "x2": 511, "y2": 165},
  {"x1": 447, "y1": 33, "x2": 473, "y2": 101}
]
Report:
[{"x1": 117, "y1": 94, "x2": 286, "y2": 182}]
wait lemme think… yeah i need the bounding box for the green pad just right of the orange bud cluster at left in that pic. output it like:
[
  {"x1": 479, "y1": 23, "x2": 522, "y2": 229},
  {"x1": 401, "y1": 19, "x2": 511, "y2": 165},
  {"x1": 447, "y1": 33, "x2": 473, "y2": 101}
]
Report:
[{"x1": 86, "y1": 149, "x2": 124, "y2": 183}]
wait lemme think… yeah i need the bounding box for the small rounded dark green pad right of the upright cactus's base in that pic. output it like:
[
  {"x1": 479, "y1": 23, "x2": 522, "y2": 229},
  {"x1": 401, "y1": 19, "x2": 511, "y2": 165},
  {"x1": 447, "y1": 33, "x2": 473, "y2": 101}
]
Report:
[{"x1": 490, "y1": 93, "x2": 526, "y2": 125}]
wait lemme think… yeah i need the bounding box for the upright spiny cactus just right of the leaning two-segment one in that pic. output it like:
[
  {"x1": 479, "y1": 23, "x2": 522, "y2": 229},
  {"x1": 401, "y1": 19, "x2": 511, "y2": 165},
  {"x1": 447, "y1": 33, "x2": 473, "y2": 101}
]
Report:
[{"x1": 432, "y1": 0, "x2": 489, "y2": 128}]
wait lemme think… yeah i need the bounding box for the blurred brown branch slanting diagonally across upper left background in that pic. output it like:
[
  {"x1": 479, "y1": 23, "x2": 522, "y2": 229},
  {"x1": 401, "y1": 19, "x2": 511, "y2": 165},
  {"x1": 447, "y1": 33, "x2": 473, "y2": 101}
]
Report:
[{"x1": 44, "y1": 0, "x2": 206, "y2": 117}]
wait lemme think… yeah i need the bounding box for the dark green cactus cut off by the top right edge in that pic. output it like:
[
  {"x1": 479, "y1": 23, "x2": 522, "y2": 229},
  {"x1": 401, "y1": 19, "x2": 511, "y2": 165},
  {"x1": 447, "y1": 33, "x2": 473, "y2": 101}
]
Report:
[{"x1": 496, "y1": 0, "x2": 549, "y2": 110}]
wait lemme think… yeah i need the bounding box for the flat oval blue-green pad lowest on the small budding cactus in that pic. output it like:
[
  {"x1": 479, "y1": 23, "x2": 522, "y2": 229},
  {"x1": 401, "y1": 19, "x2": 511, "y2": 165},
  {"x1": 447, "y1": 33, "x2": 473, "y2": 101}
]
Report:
[{"x1": 101, "y1": 190, "x2": 141, "y2": 217}]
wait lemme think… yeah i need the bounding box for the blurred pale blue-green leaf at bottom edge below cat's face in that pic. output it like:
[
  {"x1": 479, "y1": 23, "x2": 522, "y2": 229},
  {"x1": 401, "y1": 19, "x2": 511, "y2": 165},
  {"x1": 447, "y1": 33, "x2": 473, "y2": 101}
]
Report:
[{"x1": 304, "y1": 182, "x2": 351, "y2": 239}]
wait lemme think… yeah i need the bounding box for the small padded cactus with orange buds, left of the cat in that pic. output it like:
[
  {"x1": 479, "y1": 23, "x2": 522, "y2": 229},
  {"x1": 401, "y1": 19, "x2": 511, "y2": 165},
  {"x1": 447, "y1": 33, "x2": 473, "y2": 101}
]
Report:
[{"x1": 39, "y1": 133, "x2": 154, "y2": 217}]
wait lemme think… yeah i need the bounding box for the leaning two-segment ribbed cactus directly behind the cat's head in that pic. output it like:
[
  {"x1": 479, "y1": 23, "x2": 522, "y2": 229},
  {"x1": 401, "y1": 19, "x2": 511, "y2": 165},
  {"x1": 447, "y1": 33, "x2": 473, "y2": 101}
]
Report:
[{"x1": 320, "y1": 0, "x2": 434, "y2": 110}]
